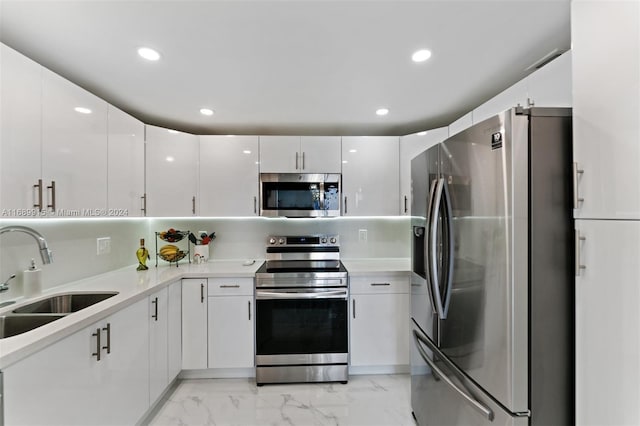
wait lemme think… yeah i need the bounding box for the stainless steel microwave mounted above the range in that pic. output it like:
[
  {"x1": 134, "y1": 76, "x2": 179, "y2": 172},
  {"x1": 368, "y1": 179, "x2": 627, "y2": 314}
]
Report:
[{"x1": 260, "y1": 173, "x2": 341, "y2": 217}]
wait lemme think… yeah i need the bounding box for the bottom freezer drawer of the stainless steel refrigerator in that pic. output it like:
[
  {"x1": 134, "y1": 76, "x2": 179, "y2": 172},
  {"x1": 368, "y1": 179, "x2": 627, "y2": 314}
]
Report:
[{"x1": 411, "y1": 322, "x2": 529, "y2": 426}]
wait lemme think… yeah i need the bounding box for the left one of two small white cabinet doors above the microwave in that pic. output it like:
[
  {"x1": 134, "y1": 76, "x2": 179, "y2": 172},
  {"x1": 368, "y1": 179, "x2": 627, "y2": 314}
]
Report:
[{"x1": 260, "y1": 136, "x2": 301, "y2": 173}]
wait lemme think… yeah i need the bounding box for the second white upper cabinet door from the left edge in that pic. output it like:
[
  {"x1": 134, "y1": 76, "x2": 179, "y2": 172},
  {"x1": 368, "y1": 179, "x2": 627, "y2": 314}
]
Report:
[{"x1": 42, "y1": 68, "x2": 107, "y2": 212}]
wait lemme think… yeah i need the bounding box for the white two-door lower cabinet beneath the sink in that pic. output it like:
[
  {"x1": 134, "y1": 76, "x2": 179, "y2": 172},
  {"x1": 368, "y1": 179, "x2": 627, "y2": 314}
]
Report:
[{"x1": 3, "y1": 300, "x2": 149, "y2": 425}]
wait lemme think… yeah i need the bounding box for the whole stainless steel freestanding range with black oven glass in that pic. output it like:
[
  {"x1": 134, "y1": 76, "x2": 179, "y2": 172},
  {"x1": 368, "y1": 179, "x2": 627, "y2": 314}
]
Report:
[{"x1": 255, "y1": 235, "x2": 349, "y2": 385}]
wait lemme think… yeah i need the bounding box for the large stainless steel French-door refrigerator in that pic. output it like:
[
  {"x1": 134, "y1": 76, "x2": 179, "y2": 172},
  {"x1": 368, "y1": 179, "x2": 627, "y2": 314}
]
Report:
[{"x1": 411, "y1": 108, "x2": 574, "y2": 425}]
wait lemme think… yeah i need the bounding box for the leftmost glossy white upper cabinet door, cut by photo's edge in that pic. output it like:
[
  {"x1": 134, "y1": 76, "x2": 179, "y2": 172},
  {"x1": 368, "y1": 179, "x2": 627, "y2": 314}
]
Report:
[{"x1": 0, "y1": 44, "x2": 42, "y2": 213}]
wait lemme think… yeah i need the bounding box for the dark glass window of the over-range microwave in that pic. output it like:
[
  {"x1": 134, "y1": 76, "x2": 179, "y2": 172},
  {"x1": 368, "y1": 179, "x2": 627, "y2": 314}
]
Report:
[{"x1": 262, "y1": 182, "x2": 320, "y2": 210}]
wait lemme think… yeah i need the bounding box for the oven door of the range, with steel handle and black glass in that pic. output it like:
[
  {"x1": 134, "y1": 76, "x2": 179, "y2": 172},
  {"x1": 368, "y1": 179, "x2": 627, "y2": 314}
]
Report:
[{"x1": 256, "y1": 287, "x2": 349, "y2": 365}]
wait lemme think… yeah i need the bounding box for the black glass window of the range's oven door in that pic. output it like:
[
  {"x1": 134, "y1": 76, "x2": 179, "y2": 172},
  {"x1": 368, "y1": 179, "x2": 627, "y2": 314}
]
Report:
[{"x1": 256, "y1": 299, "x2": 348, "y2": 355}]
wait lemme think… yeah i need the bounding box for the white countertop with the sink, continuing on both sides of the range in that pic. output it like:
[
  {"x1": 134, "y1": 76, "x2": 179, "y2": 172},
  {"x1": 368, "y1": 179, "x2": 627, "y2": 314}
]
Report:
[{"x1": 0, "y1": 258, "x2": 411, "y2": 369}]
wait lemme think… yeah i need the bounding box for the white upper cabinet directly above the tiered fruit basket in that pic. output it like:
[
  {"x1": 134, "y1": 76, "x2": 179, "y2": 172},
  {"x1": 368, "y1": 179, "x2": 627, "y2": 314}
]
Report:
[{"x1": 145, "y1": 125, "x2": 199, "y2": 217}]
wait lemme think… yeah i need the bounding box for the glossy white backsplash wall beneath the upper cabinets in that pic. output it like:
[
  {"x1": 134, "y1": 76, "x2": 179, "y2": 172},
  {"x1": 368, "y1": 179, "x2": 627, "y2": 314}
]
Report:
[{"x1": 0, "y1": 217, "x2": 411, "y2": 300}]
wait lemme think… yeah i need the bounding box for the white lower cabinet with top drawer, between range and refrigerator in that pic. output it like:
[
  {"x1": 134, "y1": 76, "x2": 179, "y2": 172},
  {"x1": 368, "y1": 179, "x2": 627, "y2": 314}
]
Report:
[{"x1": 350, "y1": 273, "x2": 409, "y2": 373}]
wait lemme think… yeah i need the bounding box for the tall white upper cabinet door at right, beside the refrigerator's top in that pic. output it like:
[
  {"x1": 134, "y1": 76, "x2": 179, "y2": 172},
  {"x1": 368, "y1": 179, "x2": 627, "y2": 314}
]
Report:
[{"x1": 571, "y1": 1, "x2": 640, "y2": 219}]
